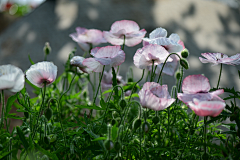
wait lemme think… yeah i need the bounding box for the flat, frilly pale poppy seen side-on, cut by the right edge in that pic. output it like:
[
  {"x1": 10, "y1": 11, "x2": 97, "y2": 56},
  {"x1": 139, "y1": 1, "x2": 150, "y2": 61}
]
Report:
[{"x1": 199, "y1": 53, "x2": 240, "y2": 66}]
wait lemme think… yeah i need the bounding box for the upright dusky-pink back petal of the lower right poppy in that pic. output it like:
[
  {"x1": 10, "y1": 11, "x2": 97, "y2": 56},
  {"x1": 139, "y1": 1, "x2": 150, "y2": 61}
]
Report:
[{"x1": 182, "y1": 74, "x2": 210, "y2": 94}]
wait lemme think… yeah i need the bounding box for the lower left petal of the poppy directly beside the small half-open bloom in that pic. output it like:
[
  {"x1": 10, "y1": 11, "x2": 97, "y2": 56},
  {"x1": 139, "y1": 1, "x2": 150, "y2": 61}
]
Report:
[{"x1": 83, "y1": 58, "x2": 103, "y2": 72}]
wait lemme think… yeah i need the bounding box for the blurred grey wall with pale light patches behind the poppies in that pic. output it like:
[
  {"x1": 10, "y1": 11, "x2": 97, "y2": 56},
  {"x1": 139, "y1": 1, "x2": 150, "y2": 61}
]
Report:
[{"x1": 0, "y1": 0, "x2": 240, "y2": 94}]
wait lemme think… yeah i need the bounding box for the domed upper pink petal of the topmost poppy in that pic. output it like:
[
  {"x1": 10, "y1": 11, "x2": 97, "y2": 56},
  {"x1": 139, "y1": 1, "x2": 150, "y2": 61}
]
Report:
[{"x1": 110, "y1": 20, "x2": 140, "y2": 33}]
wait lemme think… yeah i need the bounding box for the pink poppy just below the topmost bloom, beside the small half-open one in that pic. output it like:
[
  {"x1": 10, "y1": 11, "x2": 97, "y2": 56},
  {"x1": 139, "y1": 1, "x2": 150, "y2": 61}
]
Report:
[{"x1": 82, "y1": 46, "x2": 125, "y2": 72}]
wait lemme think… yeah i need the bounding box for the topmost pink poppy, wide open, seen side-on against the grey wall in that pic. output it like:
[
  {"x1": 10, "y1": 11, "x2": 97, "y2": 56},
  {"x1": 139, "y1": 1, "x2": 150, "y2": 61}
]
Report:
[{"x1": 103, "y1": 20, "x2": 147, "y2": 47}]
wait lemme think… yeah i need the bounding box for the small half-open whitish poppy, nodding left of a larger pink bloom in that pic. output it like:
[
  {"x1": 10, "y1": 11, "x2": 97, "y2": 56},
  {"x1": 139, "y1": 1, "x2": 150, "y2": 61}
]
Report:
[{"x1": 70, "y1": 56, "x2": 92, "y2": 73}]
